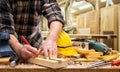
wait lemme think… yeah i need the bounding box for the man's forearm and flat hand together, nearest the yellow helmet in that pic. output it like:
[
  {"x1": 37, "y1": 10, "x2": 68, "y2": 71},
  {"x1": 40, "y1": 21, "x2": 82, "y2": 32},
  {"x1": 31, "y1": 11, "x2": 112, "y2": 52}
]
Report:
[{"x1": 39, "y1": 21, "x2": 62, "y2": 58}]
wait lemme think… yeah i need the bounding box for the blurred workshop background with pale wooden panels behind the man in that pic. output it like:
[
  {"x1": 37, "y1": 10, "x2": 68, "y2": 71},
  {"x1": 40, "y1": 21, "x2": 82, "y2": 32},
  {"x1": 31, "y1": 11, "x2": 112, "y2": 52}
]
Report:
[{"x1": 41, "y1": 0, "x2": 120, "y2": 51}]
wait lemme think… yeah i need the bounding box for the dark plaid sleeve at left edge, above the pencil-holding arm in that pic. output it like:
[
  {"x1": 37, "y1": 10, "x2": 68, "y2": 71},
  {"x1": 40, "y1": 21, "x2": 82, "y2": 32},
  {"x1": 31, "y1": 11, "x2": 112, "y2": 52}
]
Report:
[{"x1": 0, "y1": 0, "x2": 15, "y2": 34}]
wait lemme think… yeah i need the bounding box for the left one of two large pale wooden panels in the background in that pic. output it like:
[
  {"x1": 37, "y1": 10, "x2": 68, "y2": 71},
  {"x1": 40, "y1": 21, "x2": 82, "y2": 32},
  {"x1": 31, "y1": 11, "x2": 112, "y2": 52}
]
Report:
[{"x1": 76, "y1": 10, "x2": 99, "y2": 34}]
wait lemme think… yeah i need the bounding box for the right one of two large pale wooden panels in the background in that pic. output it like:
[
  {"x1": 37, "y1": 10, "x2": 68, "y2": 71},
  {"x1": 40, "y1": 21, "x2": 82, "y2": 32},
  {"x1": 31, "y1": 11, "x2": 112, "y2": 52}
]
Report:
[{"x1": 100, "y1": 5, "x2": 118, "y2": 50}]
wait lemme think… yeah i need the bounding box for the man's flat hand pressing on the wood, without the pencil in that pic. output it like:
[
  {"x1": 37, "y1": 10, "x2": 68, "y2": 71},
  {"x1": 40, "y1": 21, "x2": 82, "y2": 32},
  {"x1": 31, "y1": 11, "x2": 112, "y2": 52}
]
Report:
[{"x1": 39, "y1": 40, "x2": 57, "y2": 58}]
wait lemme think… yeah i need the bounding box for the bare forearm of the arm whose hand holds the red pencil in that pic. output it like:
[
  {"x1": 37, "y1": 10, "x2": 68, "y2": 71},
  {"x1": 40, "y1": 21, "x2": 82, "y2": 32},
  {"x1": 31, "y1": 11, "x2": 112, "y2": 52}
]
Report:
[{"x1": 9, "y1": 34, "x2": 23, "y2": 55}]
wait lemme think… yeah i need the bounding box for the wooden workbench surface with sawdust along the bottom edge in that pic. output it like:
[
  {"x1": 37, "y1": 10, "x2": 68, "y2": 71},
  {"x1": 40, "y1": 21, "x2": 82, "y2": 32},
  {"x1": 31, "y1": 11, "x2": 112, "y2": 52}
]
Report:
[{"x1": 0, "y1": 64, "x2": 120, "y2": 72}]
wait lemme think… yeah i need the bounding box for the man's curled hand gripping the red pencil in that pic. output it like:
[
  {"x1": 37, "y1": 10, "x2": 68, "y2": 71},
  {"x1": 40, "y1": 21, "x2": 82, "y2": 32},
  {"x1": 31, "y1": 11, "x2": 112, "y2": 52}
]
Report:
[{"x1": 19, "y1": 45, "x2": 39, "y2": 60}]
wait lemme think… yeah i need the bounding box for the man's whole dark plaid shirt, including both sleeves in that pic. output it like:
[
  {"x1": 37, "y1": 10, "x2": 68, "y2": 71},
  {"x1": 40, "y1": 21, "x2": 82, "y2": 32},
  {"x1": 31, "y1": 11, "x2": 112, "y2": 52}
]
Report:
[{"x1": 0, "y1": 0, "x2": 64, "y2": 47}]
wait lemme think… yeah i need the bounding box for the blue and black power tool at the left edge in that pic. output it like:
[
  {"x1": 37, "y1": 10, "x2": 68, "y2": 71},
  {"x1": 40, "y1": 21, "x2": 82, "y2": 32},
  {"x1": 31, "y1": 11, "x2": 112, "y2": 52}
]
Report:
[{"x1": 0, "y1": 32, "x2": 19, "y2": 66}]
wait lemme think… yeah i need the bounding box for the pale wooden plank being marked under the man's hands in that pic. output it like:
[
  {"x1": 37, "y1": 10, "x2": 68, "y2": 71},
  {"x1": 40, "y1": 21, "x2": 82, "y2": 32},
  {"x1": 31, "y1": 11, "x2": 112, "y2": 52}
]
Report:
[{"x1": 28, "y1": 57, "x2": 68, "y2": 69}]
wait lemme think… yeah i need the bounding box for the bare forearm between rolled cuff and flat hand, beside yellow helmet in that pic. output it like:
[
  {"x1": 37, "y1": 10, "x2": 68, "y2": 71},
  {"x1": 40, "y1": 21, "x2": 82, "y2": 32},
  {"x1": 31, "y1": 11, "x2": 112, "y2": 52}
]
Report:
[{"x1": 46, "y1": 21, "x2": 62, "y2": 42}]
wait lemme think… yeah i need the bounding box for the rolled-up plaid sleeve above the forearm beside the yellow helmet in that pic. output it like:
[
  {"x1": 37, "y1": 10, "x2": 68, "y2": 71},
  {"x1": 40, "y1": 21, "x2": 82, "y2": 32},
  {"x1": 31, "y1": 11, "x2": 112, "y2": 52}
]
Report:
[{"x1": 42, "y1": 0, "x2": 65, "y2": 26}]
